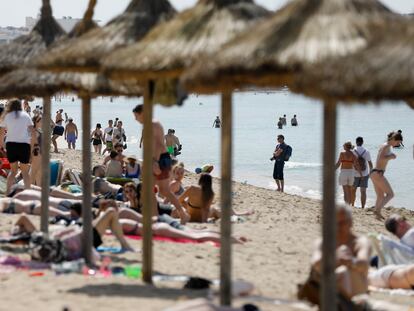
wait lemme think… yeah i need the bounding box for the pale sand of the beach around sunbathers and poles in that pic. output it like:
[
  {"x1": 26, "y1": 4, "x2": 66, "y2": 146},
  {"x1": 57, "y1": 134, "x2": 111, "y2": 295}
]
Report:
[{"x1": 0, "y1": 150, "x2": 414, "y2": 311}]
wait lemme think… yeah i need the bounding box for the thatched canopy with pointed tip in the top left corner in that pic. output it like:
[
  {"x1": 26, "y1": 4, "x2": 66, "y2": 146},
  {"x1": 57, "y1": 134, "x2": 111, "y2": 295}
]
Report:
[{"x1": 0, "y1": 0, "x2": 65, "y2": 75}]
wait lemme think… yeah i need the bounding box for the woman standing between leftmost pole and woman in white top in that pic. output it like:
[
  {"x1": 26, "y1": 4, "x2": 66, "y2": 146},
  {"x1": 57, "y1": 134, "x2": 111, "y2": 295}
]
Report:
[{"x1": 30, "y1": 115, "x2": 42, "y2": 186}]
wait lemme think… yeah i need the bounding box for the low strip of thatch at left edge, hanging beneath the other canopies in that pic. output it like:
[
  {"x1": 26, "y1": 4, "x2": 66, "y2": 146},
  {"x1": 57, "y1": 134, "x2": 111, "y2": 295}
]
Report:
[{"x1": 0, "y1": 68, "x2": 142, "y2": 98}]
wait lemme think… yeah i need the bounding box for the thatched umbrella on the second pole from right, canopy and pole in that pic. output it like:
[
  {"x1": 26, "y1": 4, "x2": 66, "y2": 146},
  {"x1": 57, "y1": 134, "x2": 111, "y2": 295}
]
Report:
[{"x1": 103, "y1": 0, "x2": 269, "y2": 305}]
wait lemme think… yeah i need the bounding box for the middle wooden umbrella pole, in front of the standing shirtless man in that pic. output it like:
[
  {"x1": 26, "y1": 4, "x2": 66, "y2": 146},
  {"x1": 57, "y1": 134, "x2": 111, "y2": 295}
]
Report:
[{"x1": 142, "y1": 81, "x2": 154, "y2": 283}]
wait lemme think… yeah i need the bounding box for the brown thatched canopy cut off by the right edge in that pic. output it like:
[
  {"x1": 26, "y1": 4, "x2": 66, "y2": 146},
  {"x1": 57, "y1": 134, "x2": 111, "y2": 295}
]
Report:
[{"x1": 291, "y1": 20, "x2": 414, "y2": 102}]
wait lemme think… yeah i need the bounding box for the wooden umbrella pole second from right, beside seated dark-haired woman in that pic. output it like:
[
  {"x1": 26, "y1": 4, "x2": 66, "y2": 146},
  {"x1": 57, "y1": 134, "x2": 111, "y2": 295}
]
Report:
[{"x1": 220, "y1": 92, "x2": 232, "y2": 306}]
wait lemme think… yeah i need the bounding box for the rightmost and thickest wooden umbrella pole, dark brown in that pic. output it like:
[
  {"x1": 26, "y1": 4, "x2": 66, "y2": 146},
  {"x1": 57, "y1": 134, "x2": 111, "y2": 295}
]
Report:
[{"x1": 321, "y1": 101, "x2": 336, "y2": 311}]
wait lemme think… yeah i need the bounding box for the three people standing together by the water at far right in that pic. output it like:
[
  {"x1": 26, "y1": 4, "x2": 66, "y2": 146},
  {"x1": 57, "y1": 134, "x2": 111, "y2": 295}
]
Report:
[{"x1": 335, "y1": 131, "x2": 403, "y2": 220}]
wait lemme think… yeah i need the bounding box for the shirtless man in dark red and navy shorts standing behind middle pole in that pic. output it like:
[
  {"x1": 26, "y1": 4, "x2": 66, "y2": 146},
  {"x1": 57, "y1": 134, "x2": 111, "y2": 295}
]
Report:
[{"x1": 132, "y1": 105, "x2": 190, "y2": 224}]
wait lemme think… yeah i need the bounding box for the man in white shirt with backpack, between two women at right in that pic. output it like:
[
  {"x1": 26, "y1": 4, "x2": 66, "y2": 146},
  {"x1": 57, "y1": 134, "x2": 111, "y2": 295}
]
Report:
[{"x1": 352, "y1": 137, "x2": 373, "y2": 208}]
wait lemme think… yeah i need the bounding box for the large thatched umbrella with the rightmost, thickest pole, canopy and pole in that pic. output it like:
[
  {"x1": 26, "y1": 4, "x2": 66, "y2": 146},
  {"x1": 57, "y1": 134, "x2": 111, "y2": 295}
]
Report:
[{"x1": 184, "y1": 0, "x2": 406, "y2": 310}]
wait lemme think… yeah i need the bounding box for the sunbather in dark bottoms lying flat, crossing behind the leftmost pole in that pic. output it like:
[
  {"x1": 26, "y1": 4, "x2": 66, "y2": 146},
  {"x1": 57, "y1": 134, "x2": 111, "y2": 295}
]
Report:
[{"x1": 0, "y1": 198, "x2": 70, "y2": 217}]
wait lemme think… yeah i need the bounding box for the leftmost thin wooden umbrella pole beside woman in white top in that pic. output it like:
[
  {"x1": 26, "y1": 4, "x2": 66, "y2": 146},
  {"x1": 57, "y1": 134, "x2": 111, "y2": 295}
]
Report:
[{"x1": 40, "y1": 97, "x2": 51, "y2": 234}]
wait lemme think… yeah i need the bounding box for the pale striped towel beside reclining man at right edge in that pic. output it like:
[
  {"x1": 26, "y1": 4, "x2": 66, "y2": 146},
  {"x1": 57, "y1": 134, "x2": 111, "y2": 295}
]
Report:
[{"x1": 370, "y1": 234, "x2": 414, "y2": 268}]
